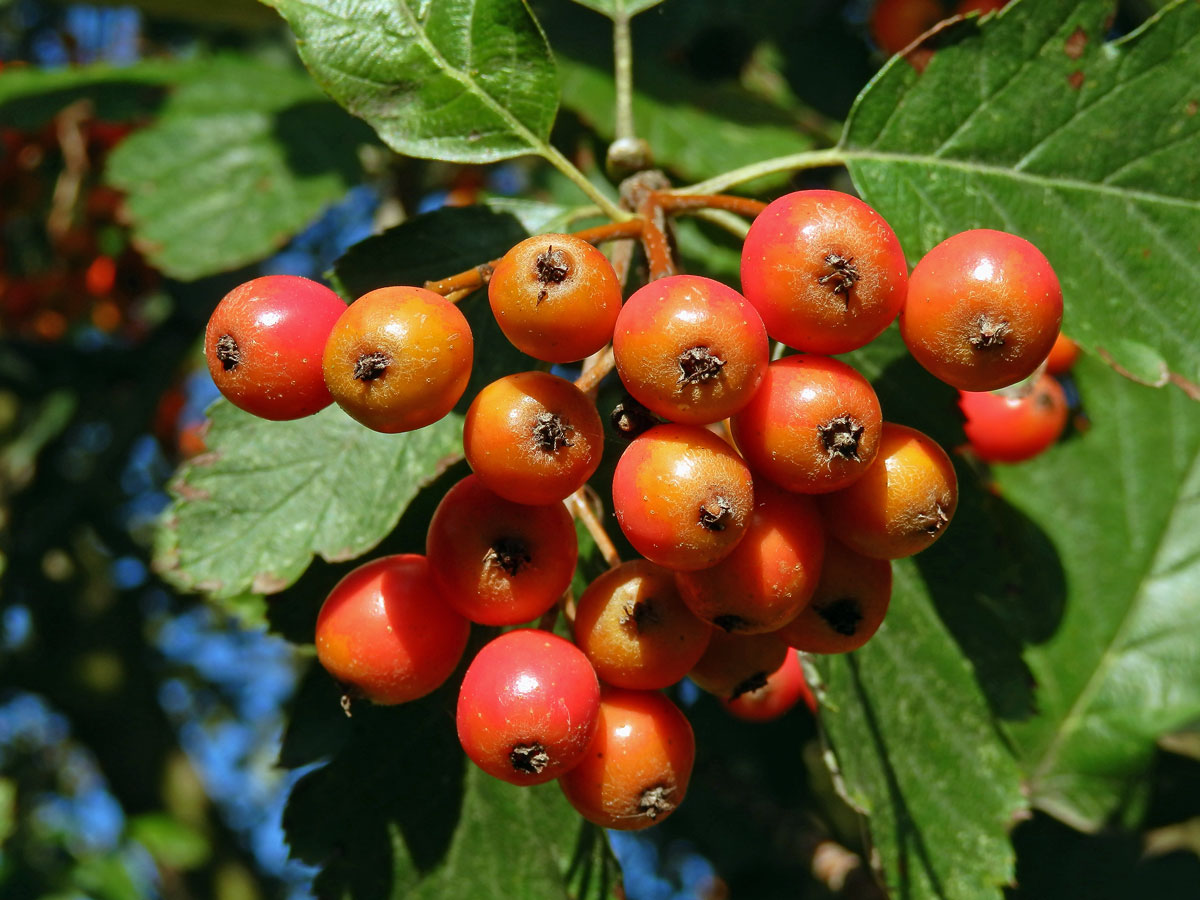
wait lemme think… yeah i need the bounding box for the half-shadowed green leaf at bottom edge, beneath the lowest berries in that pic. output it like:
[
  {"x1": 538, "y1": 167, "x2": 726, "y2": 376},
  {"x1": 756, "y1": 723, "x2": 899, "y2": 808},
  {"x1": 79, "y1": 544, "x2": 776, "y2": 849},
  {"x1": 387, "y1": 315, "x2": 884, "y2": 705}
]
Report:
[{"x1": 283, "y1": 667, "x2": 619, "y2": 900}]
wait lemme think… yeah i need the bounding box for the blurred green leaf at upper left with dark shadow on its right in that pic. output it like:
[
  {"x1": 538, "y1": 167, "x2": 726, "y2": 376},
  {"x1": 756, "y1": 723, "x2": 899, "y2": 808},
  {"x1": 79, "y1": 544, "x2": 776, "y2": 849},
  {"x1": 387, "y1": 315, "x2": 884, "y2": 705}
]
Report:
[{"x1": 107, "y1": 58, "x2": 370, "y2": 278}]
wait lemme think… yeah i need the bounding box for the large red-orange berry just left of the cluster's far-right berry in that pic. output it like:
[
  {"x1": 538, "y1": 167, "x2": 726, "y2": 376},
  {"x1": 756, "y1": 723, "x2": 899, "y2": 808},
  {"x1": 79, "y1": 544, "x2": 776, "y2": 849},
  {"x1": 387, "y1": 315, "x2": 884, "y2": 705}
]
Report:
[{"x1": 742, "y1": 191, "x2": 908, "y2": 354}]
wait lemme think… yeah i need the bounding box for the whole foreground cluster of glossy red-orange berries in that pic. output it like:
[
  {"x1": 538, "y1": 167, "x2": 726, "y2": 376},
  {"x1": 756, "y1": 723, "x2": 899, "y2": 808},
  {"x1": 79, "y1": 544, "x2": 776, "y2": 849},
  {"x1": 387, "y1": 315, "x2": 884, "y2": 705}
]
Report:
[{"x1": 205, "y1": 191, "x2": 1062, "y2": 828}]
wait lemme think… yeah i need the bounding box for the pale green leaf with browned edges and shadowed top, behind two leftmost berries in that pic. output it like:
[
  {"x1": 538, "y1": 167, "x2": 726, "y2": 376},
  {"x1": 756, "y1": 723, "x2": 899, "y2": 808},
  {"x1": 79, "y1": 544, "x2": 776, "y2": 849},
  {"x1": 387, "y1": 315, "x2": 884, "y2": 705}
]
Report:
[{"x1": 156, "y1": 208, "x2": 530, "y2": 598}]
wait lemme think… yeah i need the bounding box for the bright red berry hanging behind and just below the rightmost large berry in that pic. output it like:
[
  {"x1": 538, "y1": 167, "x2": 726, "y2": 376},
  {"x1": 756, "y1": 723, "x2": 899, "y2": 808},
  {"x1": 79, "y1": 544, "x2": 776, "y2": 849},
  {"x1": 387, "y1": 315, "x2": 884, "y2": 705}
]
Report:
[{"x1": 959, "y1": 374, "x2": 1069, "y2": 462}]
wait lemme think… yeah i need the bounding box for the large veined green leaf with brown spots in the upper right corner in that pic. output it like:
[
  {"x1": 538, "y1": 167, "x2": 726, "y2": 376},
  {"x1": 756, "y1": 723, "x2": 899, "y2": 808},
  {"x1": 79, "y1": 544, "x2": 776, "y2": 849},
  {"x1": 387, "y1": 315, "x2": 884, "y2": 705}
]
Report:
[{"x1": 842, "y1": 0, "x2": 1200, "y2": 391}]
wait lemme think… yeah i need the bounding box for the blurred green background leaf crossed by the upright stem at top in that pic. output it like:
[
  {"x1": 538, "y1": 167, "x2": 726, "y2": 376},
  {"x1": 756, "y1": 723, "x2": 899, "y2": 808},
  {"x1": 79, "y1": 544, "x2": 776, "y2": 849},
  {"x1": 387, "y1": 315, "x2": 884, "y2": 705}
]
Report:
[{"x1": 558, "y1": 58, "x2": 812, "y2": 186}]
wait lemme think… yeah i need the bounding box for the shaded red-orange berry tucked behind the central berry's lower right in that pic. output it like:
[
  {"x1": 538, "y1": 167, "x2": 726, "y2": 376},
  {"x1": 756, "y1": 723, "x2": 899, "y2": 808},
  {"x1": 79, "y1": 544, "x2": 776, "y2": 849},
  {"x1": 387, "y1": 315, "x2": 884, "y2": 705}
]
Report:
[{"x1": 676, "y1": 480, "x2": 826, "y2": 634}]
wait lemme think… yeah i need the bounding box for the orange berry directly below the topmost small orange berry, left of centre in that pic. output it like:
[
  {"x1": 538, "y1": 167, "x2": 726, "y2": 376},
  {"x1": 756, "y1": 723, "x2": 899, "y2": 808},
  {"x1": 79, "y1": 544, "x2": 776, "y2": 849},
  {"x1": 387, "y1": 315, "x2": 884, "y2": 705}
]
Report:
[{"x1": 462, "y1": 372, "x2": 604, "y2": 504}]
